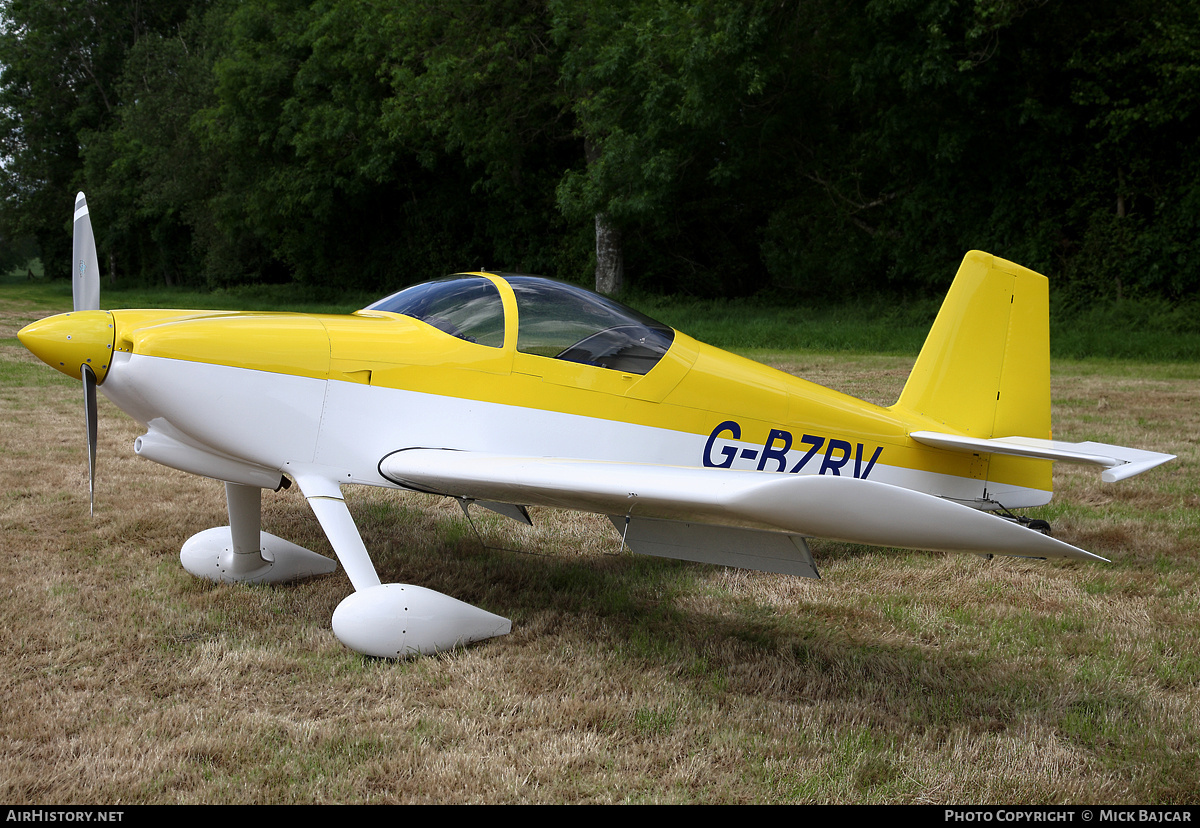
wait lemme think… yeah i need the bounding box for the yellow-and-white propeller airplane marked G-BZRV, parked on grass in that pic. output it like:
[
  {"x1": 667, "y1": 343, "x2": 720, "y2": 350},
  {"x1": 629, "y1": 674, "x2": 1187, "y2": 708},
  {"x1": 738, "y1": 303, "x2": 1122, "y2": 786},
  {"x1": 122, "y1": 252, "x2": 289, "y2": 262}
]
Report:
[{"x1": 18, "y1": 193, "x2": 1174, "y2": 658}]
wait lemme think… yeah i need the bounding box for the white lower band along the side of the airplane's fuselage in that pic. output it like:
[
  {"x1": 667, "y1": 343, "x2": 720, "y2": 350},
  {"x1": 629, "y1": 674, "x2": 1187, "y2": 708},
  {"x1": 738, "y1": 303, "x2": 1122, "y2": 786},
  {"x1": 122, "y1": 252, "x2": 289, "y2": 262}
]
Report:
[{"x1": 101, "y1": 354, "x2": 1049, "y2": 508}]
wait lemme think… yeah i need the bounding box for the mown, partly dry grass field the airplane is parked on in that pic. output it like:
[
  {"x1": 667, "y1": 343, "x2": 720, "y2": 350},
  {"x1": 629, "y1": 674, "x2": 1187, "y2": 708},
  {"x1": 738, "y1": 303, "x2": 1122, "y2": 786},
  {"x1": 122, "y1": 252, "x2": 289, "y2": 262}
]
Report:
[{"x1": 0, "y1": 277, "x2": 1200, "y2": 804}]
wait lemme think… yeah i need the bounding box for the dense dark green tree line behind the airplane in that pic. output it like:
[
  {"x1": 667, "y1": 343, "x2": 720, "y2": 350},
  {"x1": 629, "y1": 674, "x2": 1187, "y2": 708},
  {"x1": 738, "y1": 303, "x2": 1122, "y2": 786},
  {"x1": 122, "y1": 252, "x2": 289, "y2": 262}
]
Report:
[{"x1": 0, "y1": 0, "x2": 1200, "y2": 302}]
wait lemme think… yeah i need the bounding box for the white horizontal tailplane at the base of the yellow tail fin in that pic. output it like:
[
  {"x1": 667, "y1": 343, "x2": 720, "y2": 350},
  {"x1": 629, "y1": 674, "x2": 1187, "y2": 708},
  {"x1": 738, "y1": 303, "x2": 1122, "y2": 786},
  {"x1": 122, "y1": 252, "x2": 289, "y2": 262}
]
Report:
[{"x1": 908, "y1": 431, "x2": 1175, "y2": 482}]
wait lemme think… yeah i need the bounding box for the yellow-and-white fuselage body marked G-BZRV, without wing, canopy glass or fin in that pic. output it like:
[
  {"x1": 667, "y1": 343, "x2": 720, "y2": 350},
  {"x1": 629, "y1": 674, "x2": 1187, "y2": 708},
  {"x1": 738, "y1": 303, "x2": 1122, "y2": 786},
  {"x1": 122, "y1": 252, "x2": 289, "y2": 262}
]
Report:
[{"x1": 16, "y1": 276, "x2": 1050, "y2": 506}]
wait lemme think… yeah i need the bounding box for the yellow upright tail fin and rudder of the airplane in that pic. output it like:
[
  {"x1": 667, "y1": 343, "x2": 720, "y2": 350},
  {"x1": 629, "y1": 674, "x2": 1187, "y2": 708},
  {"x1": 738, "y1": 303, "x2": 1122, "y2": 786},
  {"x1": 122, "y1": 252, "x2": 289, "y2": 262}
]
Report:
[{"x1": 895, "y1": 251, "x2": 1050, "y2": 441}]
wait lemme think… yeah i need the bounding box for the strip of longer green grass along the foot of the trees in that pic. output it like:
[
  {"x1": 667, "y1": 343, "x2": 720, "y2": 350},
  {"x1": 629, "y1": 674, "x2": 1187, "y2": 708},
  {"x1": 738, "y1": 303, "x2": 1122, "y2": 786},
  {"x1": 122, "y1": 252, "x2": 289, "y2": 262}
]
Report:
[{"x1": 11, "y1": 264, "x2": 1200, "y2": 357}]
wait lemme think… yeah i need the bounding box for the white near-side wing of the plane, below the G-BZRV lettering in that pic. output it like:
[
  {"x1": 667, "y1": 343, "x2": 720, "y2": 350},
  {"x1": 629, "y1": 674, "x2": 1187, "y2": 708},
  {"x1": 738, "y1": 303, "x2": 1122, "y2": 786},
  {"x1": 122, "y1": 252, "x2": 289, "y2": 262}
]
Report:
[{"x1": 379, "y1": 449, "x2": 1104, "y2": 575}]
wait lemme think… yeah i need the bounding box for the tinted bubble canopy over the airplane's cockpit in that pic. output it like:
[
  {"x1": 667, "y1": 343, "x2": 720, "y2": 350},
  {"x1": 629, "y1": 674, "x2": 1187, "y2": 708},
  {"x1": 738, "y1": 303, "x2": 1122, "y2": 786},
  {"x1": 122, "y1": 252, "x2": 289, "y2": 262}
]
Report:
[{"x1": 365, "y1": 274, "x2": 674, "y2": 374}]
